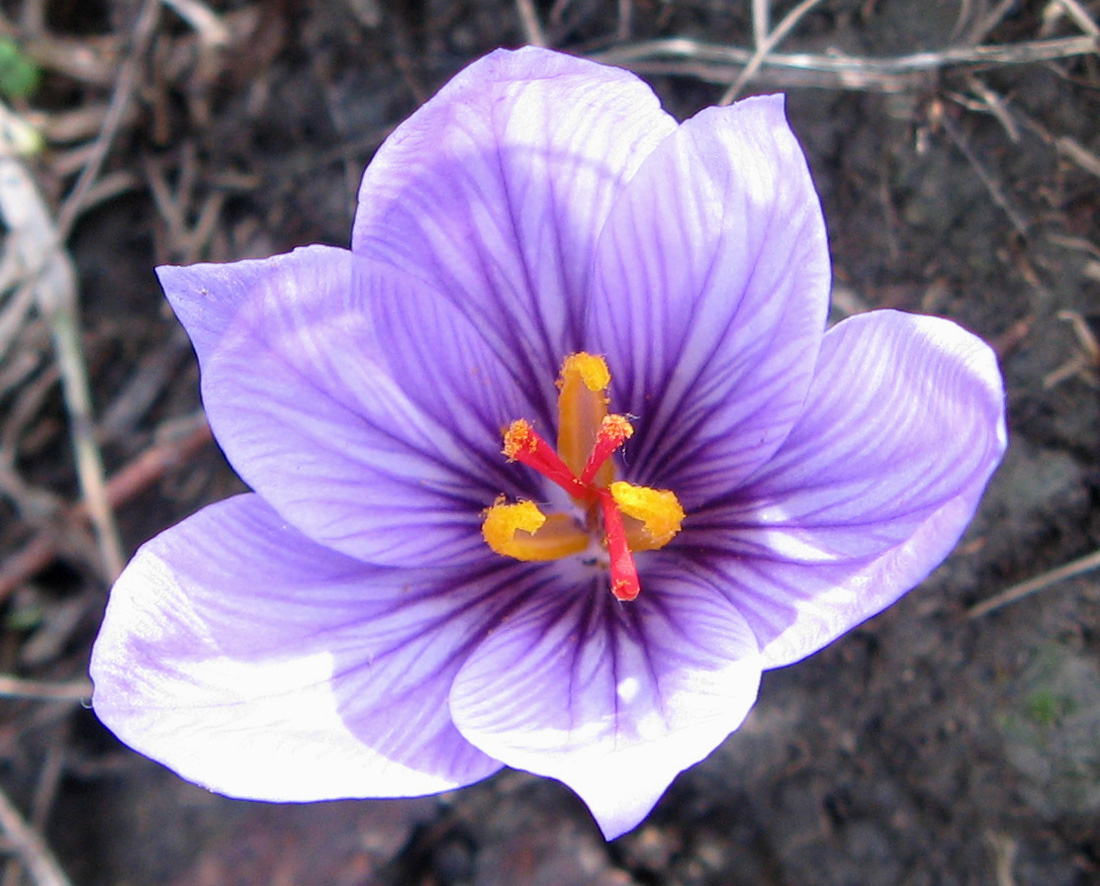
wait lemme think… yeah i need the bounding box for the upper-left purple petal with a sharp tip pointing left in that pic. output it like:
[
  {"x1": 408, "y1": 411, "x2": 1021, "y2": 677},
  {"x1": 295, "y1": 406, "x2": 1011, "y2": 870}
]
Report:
[{"x1": 162, "y1": 247, "x2": 529, "y2": 566}]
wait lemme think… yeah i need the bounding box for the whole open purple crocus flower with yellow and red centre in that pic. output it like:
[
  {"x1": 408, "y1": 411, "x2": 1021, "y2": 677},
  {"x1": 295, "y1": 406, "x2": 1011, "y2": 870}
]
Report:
[{"x1": 91, "y1": 48, "x2": 1005, "y2": 838}]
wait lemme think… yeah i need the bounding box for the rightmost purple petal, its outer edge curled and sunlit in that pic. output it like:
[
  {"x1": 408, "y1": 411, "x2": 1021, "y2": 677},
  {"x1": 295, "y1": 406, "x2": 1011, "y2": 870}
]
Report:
[{"x1": 685, "y1": 310, "x2": 1007, "y2": 667}]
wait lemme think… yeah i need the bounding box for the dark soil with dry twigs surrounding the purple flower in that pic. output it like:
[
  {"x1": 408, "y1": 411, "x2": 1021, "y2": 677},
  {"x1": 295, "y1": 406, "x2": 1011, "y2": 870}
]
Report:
[{"x1": 0, "y1": 0, "x2": 1100, "y2": 886}]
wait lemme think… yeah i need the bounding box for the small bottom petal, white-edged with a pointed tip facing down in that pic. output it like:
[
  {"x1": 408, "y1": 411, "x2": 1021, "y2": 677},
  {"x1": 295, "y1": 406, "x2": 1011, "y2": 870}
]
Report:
[{"x1": 451, "y1": 554, "x2": 760, "y2": 839}]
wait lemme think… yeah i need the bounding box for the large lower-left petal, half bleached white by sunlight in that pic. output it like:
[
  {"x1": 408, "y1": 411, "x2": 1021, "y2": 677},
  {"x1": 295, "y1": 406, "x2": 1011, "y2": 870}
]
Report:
[{"x1": 91, "y1": 495, "x2": 508, "y2": 801}]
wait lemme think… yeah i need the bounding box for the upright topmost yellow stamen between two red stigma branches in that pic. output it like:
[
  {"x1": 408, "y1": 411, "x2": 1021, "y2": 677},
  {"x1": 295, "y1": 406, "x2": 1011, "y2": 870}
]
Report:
[{"x1": 558, "y1": 351, "x2": 613, "y2": 486}]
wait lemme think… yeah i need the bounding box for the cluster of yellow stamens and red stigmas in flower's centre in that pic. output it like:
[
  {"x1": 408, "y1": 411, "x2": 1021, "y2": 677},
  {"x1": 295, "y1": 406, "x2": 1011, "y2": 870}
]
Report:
[{"x1": 482, "y1": 352, "x2": 684, "y2": 600}]
